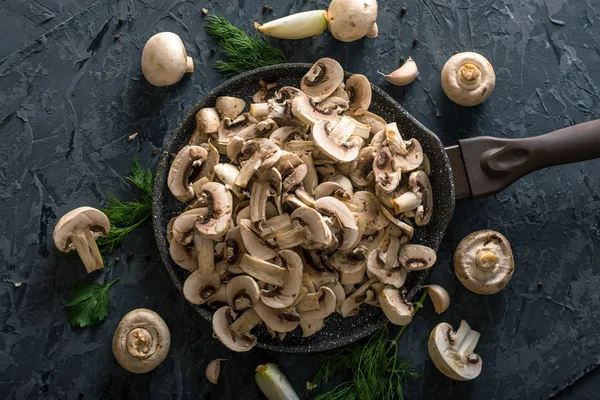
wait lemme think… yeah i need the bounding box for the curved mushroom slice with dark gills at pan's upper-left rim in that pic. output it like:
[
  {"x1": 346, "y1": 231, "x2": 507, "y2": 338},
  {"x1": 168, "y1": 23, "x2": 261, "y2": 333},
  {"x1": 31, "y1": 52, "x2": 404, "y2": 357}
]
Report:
[{"x1": 167, "y1": 146, "x2": 208, "y2": 203}]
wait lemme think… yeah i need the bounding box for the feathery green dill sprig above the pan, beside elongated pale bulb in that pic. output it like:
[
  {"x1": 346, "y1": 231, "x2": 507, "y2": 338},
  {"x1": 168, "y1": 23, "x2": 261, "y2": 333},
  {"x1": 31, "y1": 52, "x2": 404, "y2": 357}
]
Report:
[{"x1": 204, "y1": 14, "x2": 286, "y2": 75}]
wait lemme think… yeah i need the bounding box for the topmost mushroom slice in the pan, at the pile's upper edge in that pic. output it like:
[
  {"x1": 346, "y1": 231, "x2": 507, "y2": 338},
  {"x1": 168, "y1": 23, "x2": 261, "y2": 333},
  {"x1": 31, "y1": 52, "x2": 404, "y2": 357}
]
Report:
[{"x1": 300, "y1": 58, "x2": 344, "y2": 102}]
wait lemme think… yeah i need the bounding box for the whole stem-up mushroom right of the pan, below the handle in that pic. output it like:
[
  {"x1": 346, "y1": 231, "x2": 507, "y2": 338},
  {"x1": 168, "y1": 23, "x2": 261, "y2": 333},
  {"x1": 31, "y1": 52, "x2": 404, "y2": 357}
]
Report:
[{"x1": 454, "y1": 230, "x2": 515, "y2": 294}]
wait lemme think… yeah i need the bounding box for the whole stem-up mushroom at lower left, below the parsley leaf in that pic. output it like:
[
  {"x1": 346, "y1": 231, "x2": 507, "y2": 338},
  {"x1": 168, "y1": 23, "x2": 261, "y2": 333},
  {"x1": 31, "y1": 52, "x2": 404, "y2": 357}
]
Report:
[{"x1": 112, "y1": 308, "x2": 171, "y2": 374}]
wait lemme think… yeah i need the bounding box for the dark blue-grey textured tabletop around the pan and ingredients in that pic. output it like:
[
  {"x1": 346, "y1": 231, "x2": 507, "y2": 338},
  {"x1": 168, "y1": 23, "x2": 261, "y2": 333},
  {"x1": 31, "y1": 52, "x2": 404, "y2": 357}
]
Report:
[{"x1": 0, "y1": 0, "x2": 600, "y2": 399}]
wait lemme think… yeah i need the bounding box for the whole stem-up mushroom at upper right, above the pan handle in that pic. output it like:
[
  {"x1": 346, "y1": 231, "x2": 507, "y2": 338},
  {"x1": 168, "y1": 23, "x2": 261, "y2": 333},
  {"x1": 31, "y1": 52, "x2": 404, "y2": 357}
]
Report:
[{"x1": 442, "y1": 52, "x2": 496, "y2": 107}]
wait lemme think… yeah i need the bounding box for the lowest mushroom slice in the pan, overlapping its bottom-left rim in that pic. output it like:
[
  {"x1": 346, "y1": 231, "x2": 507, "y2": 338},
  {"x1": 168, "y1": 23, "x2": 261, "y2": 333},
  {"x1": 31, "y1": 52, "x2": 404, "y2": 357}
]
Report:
[{"x1": 213, "y1": 306, "x2": 261, "y2": 353}]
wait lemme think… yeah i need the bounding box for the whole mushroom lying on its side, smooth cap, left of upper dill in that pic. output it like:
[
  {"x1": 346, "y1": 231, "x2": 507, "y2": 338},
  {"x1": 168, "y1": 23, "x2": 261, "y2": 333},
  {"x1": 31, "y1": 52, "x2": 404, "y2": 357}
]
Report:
[{"x1": 142, "y1": 32, "x2": 187, "y2": 86}]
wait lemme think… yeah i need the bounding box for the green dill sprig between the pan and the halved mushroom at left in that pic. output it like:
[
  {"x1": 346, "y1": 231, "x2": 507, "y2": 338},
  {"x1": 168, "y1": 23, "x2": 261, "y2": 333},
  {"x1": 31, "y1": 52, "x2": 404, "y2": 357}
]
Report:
[{"x1": 98, "y1": 159, "x2": 153, "y2": 253}]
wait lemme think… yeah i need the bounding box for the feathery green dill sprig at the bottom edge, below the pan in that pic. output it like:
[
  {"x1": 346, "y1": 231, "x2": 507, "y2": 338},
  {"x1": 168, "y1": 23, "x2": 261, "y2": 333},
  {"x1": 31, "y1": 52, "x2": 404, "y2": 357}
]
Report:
[{"x1": 308, "y1": 290, "x2": 427, "y2": 400}]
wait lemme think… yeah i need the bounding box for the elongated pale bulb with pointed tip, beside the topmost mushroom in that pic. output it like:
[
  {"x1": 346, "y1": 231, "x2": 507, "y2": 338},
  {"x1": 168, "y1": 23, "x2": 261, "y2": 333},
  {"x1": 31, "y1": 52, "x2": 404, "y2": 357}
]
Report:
[{"x1": 254, "y1": 10, "x2": 327, "y2": 39}]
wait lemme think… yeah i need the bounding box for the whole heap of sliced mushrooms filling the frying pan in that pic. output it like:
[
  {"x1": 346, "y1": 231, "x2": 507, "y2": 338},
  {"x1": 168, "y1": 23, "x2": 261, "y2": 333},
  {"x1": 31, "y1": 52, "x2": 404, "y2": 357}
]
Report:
[{"x1": 168, "y1": 58, "x2": 436, "y2": 352}]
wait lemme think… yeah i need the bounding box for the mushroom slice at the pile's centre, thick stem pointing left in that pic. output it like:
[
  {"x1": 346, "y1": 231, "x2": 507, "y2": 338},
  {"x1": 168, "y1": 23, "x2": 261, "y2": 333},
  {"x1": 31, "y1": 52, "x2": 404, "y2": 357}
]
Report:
[{"x1": 275, "y1": 207, "x2": 331, "y2": 250}]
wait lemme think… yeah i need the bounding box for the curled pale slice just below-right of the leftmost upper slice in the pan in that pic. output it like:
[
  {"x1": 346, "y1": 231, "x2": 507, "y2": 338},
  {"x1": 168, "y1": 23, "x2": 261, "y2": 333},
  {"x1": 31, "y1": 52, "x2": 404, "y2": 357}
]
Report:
[{"x1": 195, "y1": 182, "x2": 233, "y2": 239}]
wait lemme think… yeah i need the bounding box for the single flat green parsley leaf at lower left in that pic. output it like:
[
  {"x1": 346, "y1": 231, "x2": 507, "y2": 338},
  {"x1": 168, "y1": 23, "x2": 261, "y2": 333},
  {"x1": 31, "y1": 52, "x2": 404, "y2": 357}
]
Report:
[{"x1": 67, "y1": 278, "x2": 120, "y2": 328}]
